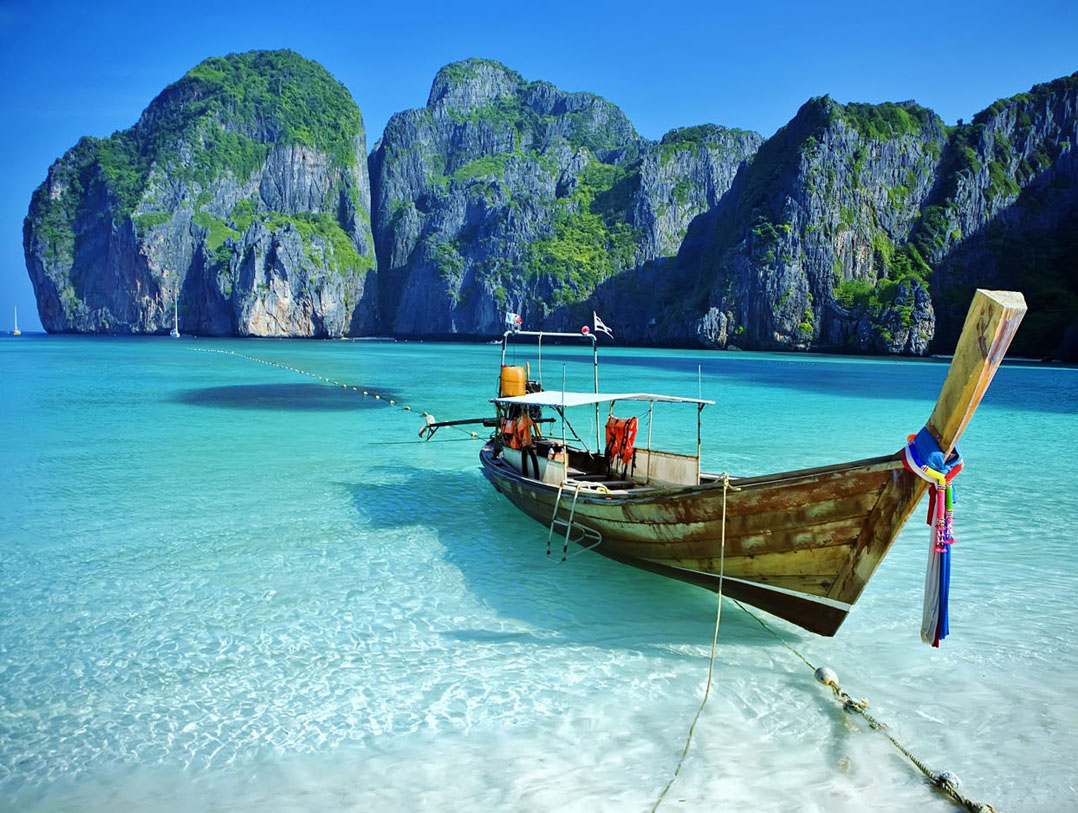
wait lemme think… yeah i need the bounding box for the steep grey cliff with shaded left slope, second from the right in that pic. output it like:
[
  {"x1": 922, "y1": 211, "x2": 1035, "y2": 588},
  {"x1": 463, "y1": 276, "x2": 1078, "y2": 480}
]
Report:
[{"x1": 660, "y1": 97, "x2": 945, "y2": 354}]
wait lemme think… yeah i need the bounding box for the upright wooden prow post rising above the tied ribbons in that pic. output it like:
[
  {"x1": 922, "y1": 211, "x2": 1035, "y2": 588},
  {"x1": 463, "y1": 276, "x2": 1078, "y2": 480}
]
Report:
[{"x1": 926, "y1": 288, "x2": 1026, "y2": 455}]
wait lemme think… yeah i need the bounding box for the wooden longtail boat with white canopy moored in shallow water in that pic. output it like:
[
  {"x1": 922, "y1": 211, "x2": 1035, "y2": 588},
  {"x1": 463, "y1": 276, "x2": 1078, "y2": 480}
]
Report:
[{"x1": 420, "y1": 290, "x2": 1026, "y2": 643}]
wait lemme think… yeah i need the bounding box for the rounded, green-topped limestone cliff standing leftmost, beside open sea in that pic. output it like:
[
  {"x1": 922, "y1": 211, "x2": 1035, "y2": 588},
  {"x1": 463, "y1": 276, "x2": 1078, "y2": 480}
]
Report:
[{"x1": 24, "y1": 52, "x2": 377, "y2": 336}]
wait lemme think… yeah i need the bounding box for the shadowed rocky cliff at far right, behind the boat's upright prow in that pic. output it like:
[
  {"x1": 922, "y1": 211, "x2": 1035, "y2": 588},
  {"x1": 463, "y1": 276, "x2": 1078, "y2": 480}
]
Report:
[{"x1": 914, "y1": 73, "x2": 1078, "y2": 353}]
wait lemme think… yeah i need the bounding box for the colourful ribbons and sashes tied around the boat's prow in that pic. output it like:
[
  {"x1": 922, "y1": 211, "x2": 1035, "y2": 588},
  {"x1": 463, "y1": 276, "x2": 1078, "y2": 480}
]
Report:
[{"x1": 902, "y1": 427, "x2": 963, "y2": 647}]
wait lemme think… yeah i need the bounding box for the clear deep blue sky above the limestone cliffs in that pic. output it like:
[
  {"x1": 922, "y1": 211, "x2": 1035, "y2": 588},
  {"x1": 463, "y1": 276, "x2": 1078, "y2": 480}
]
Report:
[{"x1": 0, "y1": 0, "x2": 1078, "y2": 330}]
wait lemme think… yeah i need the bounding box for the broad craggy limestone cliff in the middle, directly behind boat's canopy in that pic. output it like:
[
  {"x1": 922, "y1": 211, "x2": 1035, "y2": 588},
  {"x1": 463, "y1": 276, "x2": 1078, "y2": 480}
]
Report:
[{"x1": 371, "y1": 59, "x2": 760, "y2": 335}]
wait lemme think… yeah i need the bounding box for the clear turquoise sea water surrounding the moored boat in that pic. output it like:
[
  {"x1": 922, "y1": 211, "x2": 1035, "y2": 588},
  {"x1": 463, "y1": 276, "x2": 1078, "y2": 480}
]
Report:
[{"x1": 0, "y1": 336, "x2": 1078, "y2": 811}]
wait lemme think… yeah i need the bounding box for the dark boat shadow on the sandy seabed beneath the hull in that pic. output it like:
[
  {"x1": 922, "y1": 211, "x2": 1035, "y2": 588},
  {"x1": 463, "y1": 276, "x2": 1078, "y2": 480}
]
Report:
[{"x1": 341, "y1": 468, "x2": 780, "y2": 657}]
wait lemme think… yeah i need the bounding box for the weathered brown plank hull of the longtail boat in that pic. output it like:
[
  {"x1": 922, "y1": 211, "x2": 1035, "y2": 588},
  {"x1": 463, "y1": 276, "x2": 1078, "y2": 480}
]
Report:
[{"x1": 480, "y1": 444, "x2": 924, "y2": 635}]
